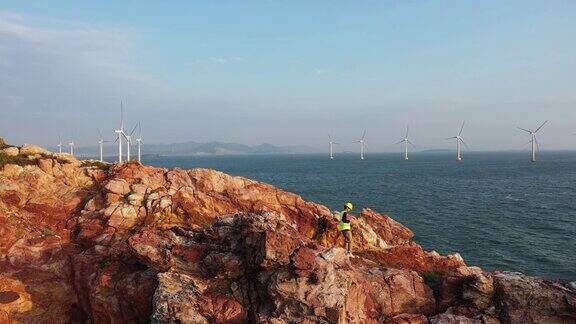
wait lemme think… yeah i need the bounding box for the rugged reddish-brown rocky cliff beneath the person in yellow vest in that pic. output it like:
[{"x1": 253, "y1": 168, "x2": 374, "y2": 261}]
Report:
[{"x1": 0, "y1": 144, "x2": 576, "y2": 323}]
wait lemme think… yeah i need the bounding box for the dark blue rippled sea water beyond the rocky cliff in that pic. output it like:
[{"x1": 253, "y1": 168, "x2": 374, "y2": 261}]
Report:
[{"x1": 144, "y1": 152, "x2": 576, "y2": 280}]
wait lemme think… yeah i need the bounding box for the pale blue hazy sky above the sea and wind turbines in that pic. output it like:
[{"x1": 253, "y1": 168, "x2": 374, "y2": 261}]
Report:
[{"x1": 0, "y1": 0, "x2": 576, "y2": 151}]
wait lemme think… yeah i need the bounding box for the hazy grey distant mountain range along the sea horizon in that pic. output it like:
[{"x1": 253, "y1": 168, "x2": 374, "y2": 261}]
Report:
[{"x1": 66, "y1": 142, "x2": 320, "y2": 156}]
